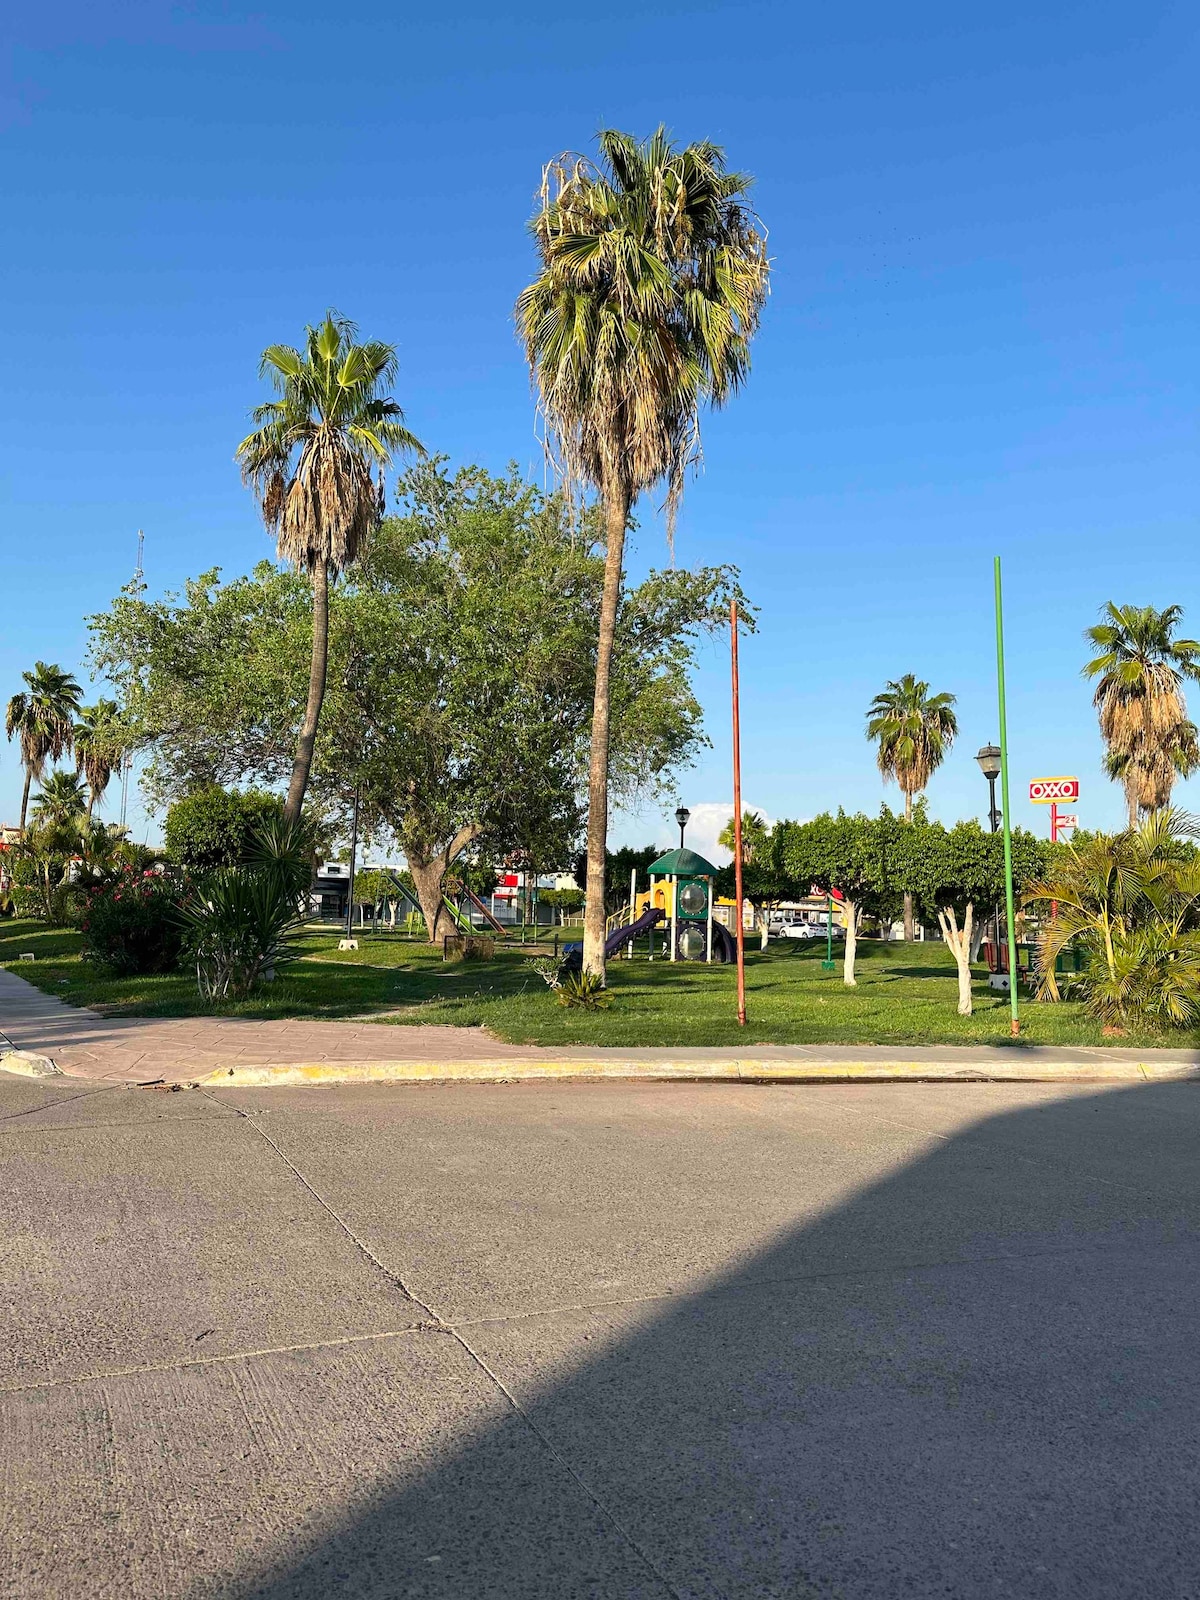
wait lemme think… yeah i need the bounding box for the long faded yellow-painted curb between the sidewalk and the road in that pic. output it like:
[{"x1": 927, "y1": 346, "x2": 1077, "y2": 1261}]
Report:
[{"x1": 198, "y1": 1056, "x2": 1200, "y2": 1088}]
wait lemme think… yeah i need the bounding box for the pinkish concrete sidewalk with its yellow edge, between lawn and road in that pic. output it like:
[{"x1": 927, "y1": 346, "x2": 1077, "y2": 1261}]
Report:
[{"x1": 0, "y1": 968, "x2": 1200, "y2": 1086}]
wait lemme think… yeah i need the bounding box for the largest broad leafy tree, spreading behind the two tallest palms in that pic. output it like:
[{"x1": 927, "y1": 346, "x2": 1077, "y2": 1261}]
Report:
[{"x1": 91, "y1": 462, "x2": 744, "y2": 941}]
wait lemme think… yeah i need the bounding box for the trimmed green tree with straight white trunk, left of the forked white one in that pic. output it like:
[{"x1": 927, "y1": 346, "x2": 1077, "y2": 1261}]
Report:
[{"x1": 776, "y1": 808, "x2": 899, "y2": 987}]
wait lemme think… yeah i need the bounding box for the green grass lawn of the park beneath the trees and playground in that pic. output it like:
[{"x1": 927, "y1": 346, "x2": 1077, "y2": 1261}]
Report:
[{"x1": 0, "y1": 922, "x2": 1197, "y2": 1051}]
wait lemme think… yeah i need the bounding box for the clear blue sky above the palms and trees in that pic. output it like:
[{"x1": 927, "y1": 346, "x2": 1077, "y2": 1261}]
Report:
[{"x1": 0, "y1": 0, "x2": 1200, "y2": 848}]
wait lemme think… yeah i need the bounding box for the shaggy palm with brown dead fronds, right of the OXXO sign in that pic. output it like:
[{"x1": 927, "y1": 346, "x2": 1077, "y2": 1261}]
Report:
[{"x1": 1083, "y1": 602, "x2": 1200, "y2": 827}]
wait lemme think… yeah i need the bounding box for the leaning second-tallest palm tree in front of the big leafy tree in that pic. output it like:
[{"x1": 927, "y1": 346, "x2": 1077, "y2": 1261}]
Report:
[{"x1": 237, "y1": 312, "x2": 424, "y2": 822}]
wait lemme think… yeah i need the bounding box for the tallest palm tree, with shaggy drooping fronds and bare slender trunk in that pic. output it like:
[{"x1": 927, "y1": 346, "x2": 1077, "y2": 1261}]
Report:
[{"x1": 517, "y1": 128, "x2": 770, "y2": 976}]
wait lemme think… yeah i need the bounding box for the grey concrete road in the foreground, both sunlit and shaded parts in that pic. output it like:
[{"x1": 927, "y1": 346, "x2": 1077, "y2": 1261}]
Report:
[{"x1": 0, "y1": 1074, "x2": 1200, "y2": 1600}]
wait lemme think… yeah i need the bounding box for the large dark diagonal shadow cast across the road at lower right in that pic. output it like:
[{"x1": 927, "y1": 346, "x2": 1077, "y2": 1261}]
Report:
[{"x1": 226, "y1": 1085, "x2": 1200, "y2": 1600}]
